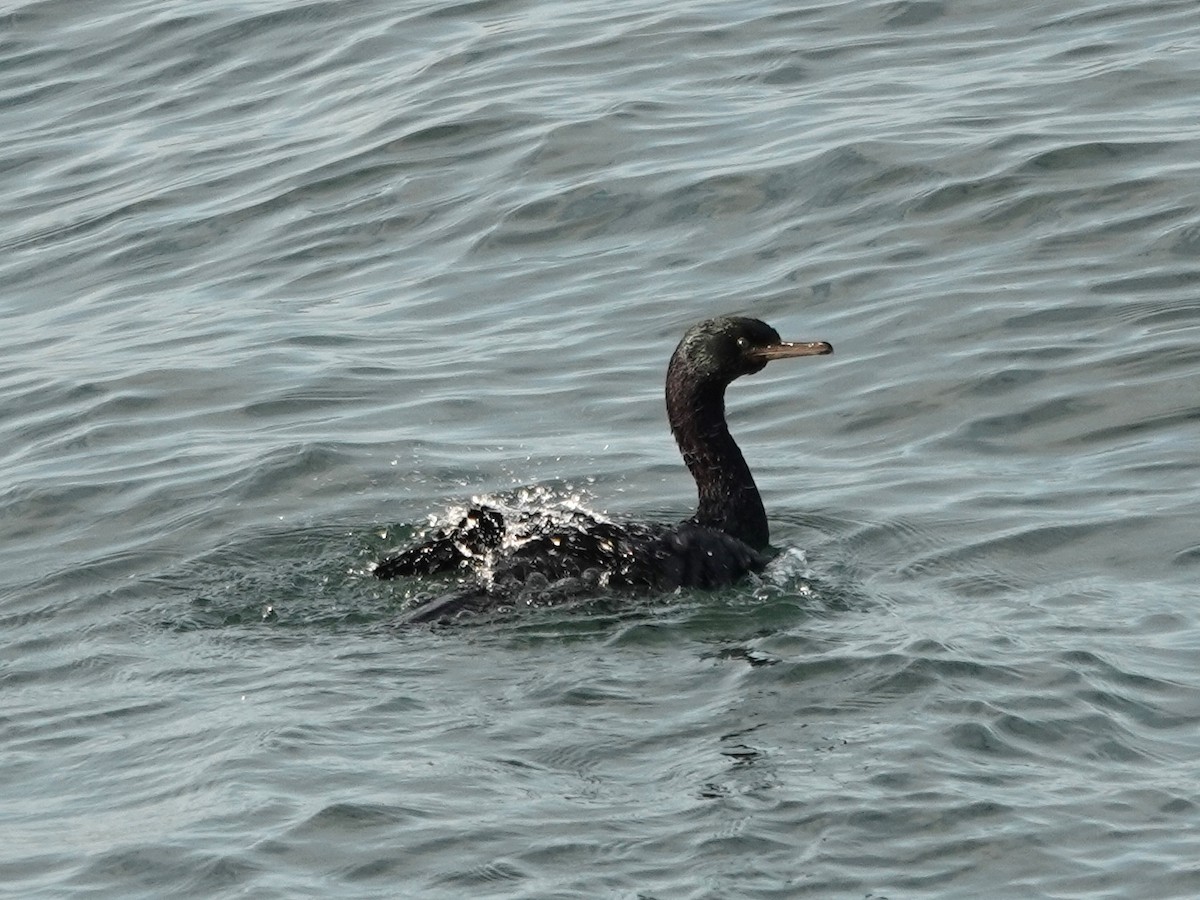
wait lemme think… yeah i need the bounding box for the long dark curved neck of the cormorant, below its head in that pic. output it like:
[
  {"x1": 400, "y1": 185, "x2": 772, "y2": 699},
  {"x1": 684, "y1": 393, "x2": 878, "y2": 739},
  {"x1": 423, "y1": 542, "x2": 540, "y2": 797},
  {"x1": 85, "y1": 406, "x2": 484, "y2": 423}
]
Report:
[{"x1": 667, "y1": 360, "x2": 770, "y2": 550}]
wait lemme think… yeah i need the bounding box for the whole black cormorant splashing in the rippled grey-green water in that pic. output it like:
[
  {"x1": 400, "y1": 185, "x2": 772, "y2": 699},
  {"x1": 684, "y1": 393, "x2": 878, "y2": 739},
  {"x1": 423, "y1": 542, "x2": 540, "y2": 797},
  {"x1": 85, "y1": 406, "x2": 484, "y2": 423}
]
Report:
[{"x1": 374, "y1": 317, "x2": 833, "y2": 622}]
